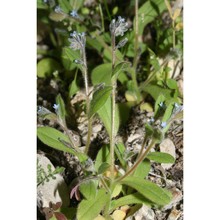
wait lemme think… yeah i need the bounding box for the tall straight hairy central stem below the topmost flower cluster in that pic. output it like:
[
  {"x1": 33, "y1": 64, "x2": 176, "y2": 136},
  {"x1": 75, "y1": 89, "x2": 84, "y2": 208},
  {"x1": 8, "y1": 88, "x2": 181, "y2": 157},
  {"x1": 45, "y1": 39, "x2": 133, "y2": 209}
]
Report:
[{"x1": 110, "y1": 33, "x2": 117, "y2": 179}]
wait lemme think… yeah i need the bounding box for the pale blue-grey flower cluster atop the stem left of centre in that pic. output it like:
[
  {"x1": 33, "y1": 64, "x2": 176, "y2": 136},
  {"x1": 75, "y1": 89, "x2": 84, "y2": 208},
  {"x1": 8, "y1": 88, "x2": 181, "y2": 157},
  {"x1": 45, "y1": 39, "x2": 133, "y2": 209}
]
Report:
[{"x1": 68, "y1": 31, "x2": 86, "y2": 50}]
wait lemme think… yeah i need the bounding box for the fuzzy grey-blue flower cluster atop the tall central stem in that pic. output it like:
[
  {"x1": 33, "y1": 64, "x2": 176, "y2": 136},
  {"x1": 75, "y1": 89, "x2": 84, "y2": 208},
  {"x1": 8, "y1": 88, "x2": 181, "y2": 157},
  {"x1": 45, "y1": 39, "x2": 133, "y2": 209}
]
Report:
[{"x1": 109, "y1": 16, "x2": 128, "y2": 37}]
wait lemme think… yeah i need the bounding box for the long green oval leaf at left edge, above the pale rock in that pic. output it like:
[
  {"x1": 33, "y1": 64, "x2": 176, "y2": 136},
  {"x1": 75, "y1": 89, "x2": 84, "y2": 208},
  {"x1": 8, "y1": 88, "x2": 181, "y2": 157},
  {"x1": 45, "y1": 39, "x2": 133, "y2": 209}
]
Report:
[{"x1": 37, "y1": 126, "x2": 87, "y2": 162}]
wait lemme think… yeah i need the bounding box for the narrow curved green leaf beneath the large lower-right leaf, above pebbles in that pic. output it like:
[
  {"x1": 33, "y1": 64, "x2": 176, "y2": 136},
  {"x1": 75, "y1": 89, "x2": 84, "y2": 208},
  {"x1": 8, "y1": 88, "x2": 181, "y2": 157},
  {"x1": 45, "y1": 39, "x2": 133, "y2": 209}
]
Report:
[{"x1": 110, "y1": 193, "x2": 153, "y2": 211}]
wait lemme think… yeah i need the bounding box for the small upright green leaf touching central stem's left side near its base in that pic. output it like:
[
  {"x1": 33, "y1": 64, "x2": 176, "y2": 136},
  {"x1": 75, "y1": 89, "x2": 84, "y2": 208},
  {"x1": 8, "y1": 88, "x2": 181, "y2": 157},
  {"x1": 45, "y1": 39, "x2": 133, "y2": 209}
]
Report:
[{"x1": 95, "y1": 145, "x2": 110, "y2": 172}]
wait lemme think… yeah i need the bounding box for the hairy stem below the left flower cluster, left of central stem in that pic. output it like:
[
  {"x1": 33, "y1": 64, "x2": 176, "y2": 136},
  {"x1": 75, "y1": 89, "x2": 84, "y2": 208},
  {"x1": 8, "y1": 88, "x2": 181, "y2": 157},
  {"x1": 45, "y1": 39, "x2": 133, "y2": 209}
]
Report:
[{"x1": 82, "y1": 47, "x2": 92, "y2": 154}]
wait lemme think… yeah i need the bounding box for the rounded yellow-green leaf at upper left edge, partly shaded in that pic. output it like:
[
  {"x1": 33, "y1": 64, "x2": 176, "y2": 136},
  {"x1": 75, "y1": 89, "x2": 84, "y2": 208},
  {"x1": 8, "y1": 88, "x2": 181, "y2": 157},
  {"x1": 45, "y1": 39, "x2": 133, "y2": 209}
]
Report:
[{"x1": 37, "y1": 58, "x2": 61, "y2": 78}]
